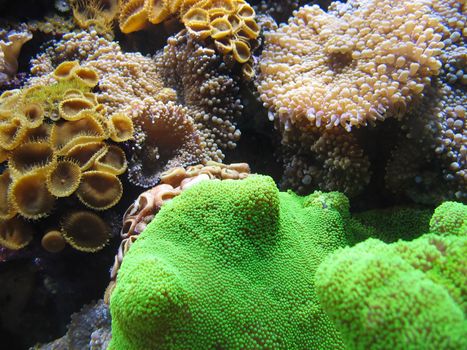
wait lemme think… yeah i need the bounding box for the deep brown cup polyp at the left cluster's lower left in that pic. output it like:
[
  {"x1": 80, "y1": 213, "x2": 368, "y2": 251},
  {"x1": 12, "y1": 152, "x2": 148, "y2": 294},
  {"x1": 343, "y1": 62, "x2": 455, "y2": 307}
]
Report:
[{"x1": 10, "y1": 169, "x2": 55, "y2": 219}]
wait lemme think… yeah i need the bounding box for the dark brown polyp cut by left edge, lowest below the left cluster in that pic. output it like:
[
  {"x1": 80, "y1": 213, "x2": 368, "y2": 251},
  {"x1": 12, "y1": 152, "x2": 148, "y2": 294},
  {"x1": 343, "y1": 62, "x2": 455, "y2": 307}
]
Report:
[{"x1": 0, "y1": 217, "x2": 34, "y2": 250}]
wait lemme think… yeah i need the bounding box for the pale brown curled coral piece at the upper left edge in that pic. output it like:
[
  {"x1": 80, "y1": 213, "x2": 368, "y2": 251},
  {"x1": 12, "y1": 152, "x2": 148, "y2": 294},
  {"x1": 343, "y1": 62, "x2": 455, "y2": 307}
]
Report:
[{"x1": 0, "y1": 29, "x2": 32, "y2": 86}]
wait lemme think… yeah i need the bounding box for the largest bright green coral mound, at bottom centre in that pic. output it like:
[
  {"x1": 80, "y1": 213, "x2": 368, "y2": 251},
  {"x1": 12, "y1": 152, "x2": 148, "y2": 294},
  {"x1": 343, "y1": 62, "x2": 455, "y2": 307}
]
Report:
[{"x1": 110, "y1": 176, "x2": 346, "y2": 350}]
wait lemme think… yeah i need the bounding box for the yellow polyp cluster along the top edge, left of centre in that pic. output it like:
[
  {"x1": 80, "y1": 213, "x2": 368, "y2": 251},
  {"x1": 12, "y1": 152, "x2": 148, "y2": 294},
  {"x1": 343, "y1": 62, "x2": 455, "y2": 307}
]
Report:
[{"x1": 120, "y1": 0, "x2": 260, "y2": 69}]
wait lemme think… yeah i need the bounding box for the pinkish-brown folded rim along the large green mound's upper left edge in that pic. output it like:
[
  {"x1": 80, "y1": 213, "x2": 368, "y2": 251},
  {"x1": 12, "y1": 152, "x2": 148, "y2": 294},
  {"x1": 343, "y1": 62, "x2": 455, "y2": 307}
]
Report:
[{"x1": 104, "y1": 161, "x2": 250, "y2": 303}]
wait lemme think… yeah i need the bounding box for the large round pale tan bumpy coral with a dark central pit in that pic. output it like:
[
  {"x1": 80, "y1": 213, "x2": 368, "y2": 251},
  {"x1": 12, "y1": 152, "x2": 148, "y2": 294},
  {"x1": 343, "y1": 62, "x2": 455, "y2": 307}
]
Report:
[{"x1": 259, "y1": 0, "x2": 444, "y2": 130}]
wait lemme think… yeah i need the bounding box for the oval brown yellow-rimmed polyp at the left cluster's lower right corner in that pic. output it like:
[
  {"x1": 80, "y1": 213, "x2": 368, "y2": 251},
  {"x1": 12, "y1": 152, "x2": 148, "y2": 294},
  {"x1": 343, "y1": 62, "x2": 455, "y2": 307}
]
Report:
[{"x1": 76, "y1": 170, "x2": 123, "y2": 210}]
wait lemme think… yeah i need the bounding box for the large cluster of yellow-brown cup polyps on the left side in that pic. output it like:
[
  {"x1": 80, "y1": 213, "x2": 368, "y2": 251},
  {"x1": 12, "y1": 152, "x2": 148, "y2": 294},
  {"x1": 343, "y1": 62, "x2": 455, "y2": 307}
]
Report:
[{"x1": 0, "y1": 62, "x2": 134, "y2": 250}]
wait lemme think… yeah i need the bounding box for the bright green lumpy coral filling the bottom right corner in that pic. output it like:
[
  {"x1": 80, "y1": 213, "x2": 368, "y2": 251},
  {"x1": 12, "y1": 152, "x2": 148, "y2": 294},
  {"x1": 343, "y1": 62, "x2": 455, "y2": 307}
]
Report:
[{"x1": 315, "y1": 201, "x2": 467, "y2": 349}]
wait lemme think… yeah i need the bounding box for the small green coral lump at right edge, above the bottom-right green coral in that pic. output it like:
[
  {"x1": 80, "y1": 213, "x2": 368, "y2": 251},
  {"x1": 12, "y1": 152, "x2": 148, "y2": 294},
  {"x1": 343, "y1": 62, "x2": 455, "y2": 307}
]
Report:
[{"x1": 430, "y1": 202, "x2": 467, "y2": 236}]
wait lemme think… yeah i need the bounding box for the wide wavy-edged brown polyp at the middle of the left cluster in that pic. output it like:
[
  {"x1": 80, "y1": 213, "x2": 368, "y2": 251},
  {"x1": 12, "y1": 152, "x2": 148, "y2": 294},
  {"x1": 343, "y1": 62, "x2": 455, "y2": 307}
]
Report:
[{"x1": 50, "y1": 114, "x2": 107, "y2": 155}]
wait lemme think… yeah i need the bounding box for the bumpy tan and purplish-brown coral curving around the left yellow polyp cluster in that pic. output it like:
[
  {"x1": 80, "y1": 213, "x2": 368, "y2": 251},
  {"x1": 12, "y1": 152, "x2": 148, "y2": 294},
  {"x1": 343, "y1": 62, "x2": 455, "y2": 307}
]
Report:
[{"x1": 31, "y1": 31, "x2": 242, "y2": 187}]
